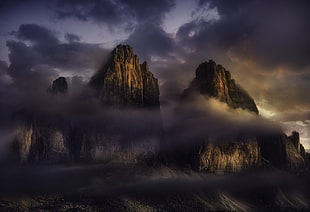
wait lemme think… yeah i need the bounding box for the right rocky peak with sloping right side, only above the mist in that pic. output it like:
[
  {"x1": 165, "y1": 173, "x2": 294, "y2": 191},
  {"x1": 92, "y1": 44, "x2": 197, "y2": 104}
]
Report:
[{"x1": 183, "y1": 60, "x2": 258, "y2": 114}]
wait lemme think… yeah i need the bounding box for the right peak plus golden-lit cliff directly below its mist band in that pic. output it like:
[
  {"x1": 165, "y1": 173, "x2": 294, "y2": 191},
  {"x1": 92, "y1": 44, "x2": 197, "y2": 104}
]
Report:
[{"x1": 172, "y1": 60, "x2": 261, "y2": 173}]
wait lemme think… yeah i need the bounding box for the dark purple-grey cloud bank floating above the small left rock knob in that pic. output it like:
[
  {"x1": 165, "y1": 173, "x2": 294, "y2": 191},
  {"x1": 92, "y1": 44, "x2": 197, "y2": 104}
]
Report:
[{"x1": 7, "y1": 24, "x2": 111, "y2": 90}]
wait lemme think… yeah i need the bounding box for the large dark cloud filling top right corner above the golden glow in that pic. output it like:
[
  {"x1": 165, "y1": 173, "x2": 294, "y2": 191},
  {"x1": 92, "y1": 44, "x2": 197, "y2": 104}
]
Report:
[{"x1": 186, "y1": 0, "x2": 310, "y2": 71}]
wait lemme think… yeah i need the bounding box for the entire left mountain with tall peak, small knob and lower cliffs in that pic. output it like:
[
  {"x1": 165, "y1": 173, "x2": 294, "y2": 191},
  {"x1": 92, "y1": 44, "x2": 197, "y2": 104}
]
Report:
[{"x1": 13, "y1": 45, "x2": 161, "y2": 164}]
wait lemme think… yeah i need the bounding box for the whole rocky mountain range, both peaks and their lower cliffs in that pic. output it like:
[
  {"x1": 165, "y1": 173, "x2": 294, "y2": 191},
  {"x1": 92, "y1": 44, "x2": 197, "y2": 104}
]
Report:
[{"x1": 13, "y1": 45, "x2": 305, "y2": 172}]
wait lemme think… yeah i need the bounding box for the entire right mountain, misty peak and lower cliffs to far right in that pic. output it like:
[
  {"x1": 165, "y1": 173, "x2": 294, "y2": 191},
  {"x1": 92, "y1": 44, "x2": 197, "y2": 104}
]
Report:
[{"x1": 163, "y1": 60, "x2": 305, "y2": 172}]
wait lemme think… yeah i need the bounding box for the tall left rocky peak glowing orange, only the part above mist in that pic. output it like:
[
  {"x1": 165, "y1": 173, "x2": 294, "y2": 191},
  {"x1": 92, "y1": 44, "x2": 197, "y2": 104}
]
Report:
[{"x1": 90, "y1": 45, "x2": 159, "y2": 108}]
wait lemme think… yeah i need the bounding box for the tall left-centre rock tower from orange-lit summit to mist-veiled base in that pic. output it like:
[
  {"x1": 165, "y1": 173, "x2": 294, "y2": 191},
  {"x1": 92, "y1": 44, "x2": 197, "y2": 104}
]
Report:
[{"x1": 84, "y1": 45, "x2": 161, "y2": 163}]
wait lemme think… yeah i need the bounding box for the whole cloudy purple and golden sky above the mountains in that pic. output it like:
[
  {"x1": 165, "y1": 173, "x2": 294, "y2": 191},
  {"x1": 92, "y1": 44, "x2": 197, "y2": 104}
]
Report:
[{"x1": 0, "y1": 0, "x2": 310, "y2": 149}]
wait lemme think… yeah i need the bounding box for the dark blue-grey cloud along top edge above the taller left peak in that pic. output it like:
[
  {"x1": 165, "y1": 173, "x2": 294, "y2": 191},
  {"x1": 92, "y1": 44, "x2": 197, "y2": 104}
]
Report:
[{"x1": 58, "y1": 0, "x2": 174, "y2": 29}]
